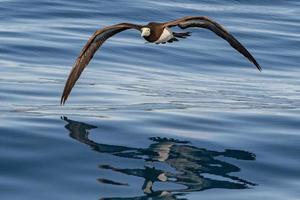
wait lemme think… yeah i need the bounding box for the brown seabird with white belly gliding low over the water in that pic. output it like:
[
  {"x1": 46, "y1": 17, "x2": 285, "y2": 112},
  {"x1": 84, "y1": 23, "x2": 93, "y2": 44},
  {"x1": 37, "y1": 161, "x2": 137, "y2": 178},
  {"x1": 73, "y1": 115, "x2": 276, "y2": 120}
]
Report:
[{"x1": 60, "y1": 16, "x2": 262, "y2": 105}]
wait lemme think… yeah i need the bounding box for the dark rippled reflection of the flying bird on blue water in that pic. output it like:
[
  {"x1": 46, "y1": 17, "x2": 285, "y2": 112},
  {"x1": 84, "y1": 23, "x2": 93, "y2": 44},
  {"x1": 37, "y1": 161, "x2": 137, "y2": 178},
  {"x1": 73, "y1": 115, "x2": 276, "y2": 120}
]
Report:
[{"x1": 62, "y1": 117, "x2": 255, "y2": 199}]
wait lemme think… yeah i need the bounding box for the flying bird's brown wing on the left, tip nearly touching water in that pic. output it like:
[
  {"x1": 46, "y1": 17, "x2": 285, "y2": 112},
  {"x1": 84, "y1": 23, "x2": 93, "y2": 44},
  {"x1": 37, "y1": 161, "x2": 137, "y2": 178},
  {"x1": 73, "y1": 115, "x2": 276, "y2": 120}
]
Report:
[{"x1": 60, "y1": 23, "x2": 141, "y2": 104}]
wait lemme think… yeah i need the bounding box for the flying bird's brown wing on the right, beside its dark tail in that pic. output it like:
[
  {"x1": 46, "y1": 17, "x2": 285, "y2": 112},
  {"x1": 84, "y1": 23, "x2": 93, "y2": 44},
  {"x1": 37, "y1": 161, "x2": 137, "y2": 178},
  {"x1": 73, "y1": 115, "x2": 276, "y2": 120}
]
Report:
[{"x1": 163, "y1": 16, "x2": 261, "y2": 71}]
